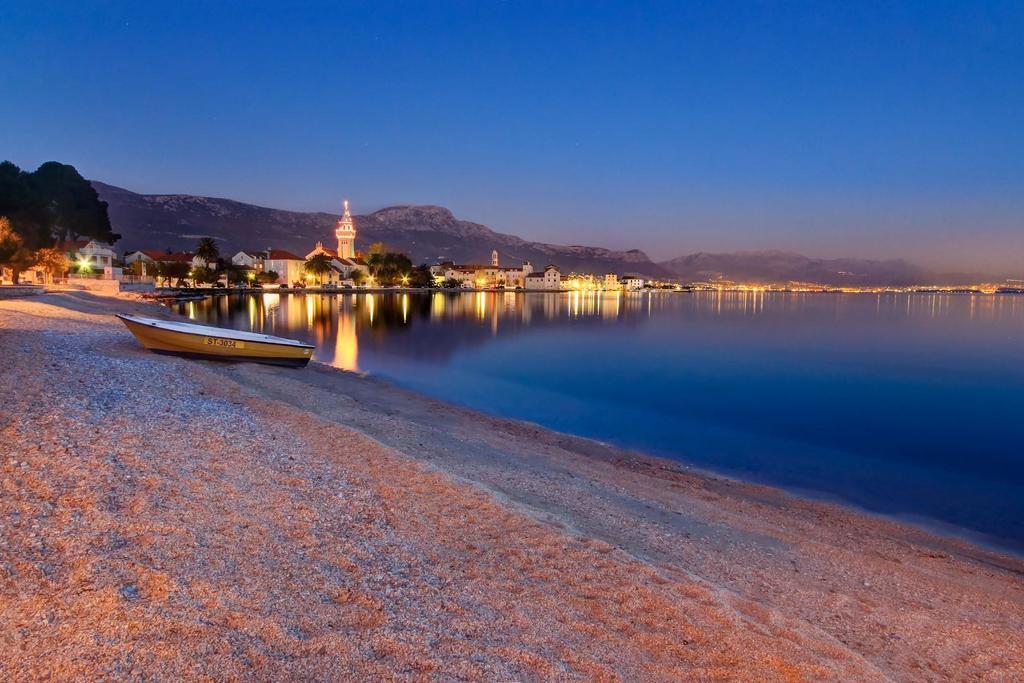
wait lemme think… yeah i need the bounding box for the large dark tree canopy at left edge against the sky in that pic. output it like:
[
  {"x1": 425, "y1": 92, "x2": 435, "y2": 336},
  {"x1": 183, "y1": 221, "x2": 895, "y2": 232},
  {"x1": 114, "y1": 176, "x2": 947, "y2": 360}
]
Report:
[{"x1": 0, "y1": 162, "x2": 121, "y2": 251}]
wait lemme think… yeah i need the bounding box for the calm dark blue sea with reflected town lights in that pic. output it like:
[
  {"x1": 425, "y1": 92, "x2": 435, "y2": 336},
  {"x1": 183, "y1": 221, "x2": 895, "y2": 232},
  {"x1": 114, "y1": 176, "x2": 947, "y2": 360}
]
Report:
[{"x1": 177, "y1": 293, "x2": 1024, "y2": 551}]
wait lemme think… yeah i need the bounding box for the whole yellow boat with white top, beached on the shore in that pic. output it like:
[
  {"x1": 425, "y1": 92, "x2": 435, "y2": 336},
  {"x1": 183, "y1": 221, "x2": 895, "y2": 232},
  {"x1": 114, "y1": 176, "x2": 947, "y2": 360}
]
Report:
[{"x1": 118, "y1": 313, "x2": 315, "y2": 368}]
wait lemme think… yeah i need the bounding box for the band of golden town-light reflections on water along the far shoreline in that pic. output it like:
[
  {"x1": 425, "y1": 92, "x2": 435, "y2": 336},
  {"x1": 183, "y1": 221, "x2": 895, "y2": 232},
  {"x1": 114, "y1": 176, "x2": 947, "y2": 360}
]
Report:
[{"x1": 176, "y1": 290, "x2": 1024, "y2": 370}]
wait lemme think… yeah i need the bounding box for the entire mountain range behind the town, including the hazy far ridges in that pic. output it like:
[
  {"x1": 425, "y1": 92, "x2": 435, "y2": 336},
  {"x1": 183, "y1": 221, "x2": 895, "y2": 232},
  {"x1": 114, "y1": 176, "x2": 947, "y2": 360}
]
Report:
[{"x1": 92, "y1": 180, "x2": 986, "y2": 286}]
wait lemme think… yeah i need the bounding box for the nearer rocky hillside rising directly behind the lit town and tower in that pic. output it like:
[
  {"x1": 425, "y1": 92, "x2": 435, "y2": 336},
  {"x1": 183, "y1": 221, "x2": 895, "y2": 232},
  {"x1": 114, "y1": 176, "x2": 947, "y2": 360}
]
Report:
[{"x1": 92, "y1": 180, "x2": 671, "y2": 276}]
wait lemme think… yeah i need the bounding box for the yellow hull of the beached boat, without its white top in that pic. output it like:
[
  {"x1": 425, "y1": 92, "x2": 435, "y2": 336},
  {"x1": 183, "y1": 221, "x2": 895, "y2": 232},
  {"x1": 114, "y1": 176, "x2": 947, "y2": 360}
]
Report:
[{"x1": 118, "y1": 315, "x2": 312, "y2": 368}]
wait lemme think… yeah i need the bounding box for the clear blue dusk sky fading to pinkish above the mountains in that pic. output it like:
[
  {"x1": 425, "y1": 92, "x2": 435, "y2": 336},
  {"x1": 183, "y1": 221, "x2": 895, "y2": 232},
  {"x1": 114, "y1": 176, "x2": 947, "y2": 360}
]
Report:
[{"x1": 0, "y1": 0, "x2": 1024, "y2": 272}]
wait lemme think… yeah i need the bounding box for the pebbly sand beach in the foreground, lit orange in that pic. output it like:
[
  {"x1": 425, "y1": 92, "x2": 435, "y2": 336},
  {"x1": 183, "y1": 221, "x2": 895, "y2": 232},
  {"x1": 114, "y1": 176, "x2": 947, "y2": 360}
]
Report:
[{"x1": 0, "y1": 293, "x2": 1024, "y2": 681}]
